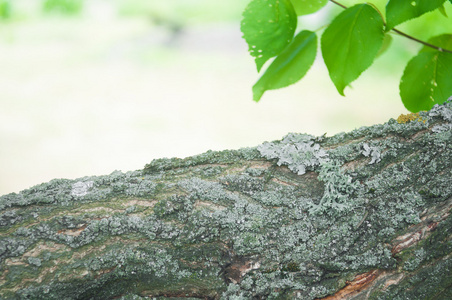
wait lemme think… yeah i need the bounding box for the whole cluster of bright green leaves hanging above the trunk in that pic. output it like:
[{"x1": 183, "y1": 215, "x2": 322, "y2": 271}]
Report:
[{"x1": 241, "y1": 0, "x2": 452, "y2": 112}]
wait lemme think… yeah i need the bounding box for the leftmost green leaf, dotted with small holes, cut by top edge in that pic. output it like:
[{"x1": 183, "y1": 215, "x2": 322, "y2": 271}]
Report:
[{"x1": 241, "y1": 0, "x2": 297, "y2": 71}]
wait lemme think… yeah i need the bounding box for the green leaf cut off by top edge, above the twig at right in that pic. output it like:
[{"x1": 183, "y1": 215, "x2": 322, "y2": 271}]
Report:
[{"x1": 386, "y1": 0, "x2": 446, "y2": 31}]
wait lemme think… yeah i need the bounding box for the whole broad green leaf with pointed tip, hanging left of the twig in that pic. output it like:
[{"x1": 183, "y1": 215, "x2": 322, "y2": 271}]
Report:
[{"x1": 321, "y1": 4, "x2": 384, "y2": 96}]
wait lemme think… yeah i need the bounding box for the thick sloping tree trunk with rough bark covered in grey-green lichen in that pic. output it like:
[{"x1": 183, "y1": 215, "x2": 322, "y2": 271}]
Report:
[{"x1": 0, "y1": 103, "x2": 452, "y2": 300}]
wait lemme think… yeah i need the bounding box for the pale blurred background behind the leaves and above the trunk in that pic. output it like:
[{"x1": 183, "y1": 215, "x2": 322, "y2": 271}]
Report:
[{"x1": 0, "y1": 0, "x2": 452, "y2": 195}]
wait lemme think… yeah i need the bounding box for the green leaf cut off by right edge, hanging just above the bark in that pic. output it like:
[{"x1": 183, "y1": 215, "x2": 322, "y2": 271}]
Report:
[{"x1": 399, "y1": 34, "x2": 452, "y2": 112}]
